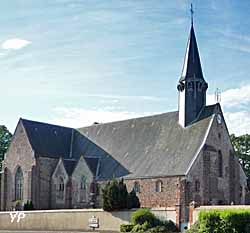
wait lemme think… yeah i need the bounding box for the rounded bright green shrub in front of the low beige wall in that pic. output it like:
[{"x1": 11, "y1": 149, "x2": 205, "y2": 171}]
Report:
[{"x1": 131, "y1": 209, "x2": 156, "y2": 226}]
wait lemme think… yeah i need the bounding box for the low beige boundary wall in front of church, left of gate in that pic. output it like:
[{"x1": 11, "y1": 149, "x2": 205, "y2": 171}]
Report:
[{"x1": 0, "y1": 208, "x2": 176, "y2": 232}]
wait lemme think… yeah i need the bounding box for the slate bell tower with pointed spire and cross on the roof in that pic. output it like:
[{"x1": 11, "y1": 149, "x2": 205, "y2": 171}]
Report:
[{"x1": 177, "y1": 4, "x2": 208, "y2": 127}]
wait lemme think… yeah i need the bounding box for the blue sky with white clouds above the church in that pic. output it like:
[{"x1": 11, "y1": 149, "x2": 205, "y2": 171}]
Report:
[{"x1": 0, "y1": 0, "x2": 250, "y2": 134}]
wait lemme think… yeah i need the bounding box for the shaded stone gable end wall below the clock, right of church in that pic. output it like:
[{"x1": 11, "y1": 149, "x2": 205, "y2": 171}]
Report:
[{"x1": 186, "y1": 111, "x2": 246, "y2": 209}]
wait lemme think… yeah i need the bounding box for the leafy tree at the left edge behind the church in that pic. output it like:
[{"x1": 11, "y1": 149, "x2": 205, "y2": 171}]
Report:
[{"x1": 0, "y1": 125, "x2": 12, "y2": 168}]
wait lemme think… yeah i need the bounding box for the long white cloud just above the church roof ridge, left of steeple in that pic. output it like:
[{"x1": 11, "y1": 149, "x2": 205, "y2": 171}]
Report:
[{"x1": 51, "y1": 107, "x2": 155, "y2": 128}]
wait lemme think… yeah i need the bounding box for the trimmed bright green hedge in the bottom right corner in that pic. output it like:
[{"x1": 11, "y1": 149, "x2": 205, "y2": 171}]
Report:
[{"x1": 189, "y1": 209, "x2": 250, "y2": 233}]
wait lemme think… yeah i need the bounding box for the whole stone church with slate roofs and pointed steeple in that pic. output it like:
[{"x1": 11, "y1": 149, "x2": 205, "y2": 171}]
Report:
[{"x1": 1, "y1": 22, "x2": 247, "y2": 226}]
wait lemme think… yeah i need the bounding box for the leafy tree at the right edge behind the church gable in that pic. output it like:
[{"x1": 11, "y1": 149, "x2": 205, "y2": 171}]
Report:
[{"x1": 230, "y1": 134, "x2": 250, "y2": 178}]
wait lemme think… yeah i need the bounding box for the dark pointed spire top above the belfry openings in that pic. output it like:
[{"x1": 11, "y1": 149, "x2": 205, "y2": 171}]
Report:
[{"x1": 180, "y1": 24, "x2": 204, "y2": 82}]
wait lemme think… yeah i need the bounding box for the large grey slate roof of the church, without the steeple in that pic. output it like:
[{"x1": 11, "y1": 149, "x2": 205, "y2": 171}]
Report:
[{"x1": 22, "y1": 105, "x2": 219, "y2": 180}]
